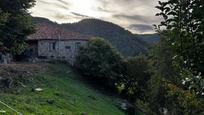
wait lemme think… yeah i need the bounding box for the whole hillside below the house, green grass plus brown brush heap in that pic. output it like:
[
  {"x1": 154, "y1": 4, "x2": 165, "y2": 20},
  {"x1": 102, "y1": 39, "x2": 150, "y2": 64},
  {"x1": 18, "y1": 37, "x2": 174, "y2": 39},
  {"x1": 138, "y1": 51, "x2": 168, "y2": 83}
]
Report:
[{"x1": 0, "y1": 63, "x2": 124, "y2": 115}]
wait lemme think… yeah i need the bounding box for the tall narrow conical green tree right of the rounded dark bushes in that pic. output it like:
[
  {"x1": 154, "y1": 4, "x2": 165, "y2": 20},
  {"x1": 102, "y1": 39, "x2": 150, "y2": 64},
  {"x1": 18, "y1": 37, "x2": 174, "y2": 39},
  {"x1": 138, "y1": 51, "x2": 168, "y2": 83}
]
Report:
[{"x1": 147, "y1": 36, "x2": 179, "y2": 114}]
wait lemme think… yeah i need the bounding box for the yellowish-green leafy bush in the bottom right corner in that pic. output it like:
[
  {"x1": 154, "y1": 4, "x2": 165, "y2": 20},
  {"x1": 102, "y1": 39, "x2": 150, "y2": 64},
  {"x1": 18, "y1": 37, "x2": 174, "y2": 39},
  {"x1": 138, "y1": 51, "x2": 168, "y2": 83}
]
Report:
[{"x1": 165, "y1": 81, "x2": 204, "y2": 115}]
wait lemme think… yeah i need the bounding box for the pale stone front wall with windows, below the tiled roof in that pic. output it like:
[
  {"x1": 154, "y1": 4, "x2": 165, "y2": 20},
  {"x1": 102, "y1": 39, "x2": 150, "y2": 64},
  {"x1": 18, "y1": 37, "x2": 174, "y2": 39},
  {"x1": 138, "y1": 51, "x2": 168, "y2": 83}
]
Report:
[{"x1": 38, "y1": 40, "x2": 87, "y2": 65}]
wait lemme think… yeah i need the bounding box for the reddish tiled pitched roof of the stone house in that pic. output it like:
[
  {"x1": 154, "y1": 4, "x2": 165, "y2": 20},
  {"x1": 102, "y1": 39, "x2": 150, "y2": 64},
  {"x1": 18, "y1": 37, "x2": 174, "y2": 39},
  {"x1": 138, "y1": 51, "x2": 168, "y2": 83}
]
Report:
[{"x1": 27, "y1": 23, "x2": 91, "y2": 41}]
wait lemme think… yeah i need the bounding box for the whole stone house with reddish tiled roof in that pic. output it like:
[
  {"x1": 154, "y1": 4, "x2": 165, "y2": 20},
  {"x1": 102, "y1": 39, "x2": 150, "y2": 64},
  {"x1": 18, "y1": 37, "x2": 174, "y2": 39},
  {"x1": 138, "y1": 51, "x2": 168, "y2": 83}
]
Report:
[{"x1": 27, "y1": 24, "x2": 91, "y2": 65}]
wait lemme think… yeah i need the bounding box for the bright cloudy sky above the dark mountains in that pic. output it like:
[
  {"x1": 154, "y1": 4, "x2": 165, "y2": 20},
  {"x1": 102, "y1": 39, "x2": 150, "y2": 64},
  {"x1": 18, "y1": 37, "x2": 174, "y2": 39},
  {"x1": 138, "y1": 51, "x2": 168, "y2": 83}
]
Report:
[{"x1": 30, "y1": 0, "x2": 161, "y2": 34}]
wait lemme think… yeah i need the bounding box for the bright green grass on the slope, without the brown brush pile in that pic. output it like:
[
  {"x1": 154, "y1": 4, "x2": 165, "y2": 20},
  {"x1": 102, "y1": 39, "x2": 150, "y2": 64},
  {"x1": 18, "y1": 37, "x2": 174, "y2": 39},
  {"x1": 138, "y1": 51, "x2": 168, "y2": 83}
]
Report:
[{"x1": 0, "y1": 64, "x2": 124, "y2": 115}]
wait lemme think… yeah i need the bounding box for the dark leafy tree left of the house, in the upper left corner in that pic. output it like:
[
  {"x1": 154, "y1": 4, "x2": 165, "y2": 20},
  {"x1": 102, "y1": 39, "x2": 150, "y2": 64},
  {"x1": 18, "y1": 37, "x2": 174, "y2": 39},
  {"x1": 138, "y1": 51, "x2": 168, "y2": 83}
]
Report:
[{"x1": 0, "y1": 0, "x2": 35, "y2": 55}]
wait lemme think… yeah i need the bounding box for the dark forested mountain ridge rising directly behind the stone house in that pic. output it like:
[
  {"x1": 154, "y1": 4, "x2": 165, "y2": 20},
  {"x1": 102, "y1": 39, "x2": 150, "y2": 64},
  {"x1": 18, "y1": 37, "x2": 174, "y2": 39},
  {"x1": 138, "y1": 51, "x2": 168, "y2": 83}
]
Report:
[{"x1": 33, "y1": 18, "x2": 150, "y2": 56}]
